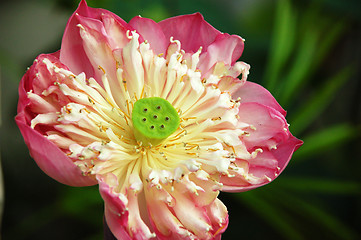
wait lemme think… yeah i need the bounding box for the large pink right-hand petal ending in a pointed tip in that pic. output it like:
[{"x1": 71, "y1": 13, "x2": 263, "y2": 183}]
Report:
[{"x1": 221, "y1": 102, "x2": 302, "y2": 192}]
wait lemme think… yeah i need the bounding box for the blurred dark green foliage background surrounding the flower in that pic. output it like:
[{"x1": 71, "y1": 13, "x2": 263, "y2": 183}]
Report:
[{"x1": 0, "y1": 0, "x2": 361, "y2": 240}]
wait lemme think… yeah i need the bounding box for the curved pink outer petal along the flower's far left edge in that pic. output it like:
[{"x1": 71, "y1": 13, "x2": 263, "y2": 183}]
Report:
[{"x1": 15, "y1": 53, "x2": 96, "y2": 186}]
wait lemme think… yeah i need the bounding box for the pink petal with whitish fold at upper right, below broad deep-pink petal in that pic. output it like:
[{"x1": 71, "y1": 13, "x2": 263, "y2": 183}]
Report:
[{"x1": 198, "y1": 34, "x2": 244, "y2": 74}]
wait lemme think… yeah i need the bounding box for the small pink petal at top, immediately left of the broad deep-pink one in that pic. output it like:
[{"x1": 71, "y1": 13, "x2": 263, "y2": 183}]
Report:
[{"x1": 129, "y1": 16, "x2": 169, "y2": 54}]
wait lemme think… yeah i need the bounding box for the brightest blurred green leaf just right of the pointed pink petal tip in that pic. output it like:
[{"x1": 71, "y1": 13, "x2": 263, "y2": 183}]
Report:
[{"x1": 293, "y1": 123, "x2": 360, "y2": 162}]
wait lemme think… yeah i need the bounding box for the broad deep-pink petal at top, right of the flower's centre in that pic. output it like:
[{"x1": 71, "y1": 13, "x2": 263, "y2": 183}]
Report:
[{"x1": 159, "y1": 13, "x2": 222, "y2": 53}]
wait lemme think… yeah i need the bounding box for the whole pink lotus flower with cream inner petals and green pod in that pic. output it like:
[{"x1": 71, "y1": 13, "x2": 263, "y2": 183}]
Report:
[{"x1": 16, "y1": 1, "x2": 302, "y2": 239}]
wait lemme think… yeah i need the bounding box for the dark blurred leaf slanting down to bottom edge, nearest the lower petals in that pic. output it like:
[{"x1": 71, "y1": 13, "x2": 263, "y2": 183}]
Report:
[{"x1": 235, "y1": 191, "x2": 303, "y2": 240}]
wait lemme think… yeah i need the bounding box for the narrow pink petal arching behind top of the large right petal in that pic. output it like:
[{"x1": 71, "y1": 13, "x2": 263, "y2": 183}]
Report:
[{"x1": 233, "y1": 82, "x2": 286, "y2": 116}]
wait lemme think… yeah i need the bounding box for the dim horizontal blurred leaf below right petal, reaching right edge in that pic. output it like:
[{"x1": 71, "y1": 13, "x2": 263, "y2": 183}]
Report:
[{"x1": 277, "y1": 176, "x2": 361, "y2": 194}]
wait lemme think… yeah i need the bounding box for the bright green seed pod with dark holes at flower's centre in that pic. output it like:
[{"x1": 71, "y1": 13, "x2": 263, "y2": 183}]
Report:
[{"x1": 132, "y1": 97, "x2": 180, "y2": 145}]
